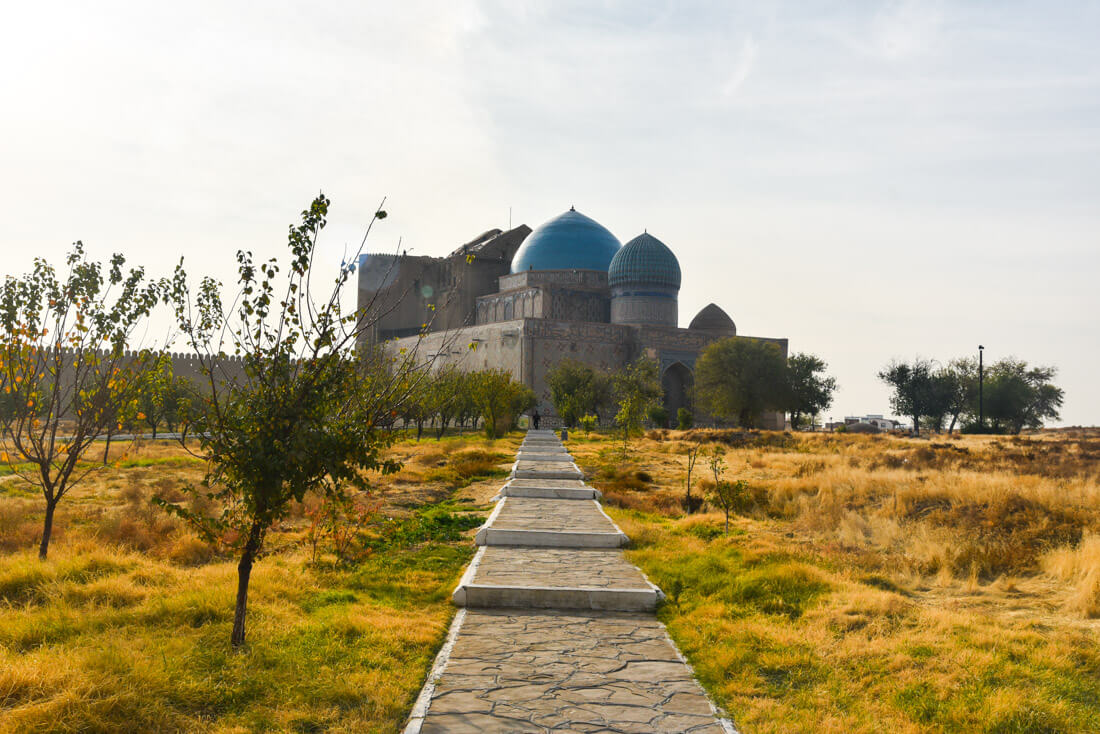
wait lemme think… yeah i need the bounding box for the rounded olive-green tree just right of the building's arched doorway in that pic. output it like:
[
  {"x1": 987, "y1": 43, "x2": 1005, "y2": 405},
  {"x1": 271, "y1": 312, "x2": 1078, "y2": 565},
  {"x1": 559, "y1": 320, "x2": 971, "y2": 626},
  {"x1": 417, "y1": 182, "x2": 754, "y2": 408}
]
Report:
[{"x1": 695, "y1": 337, "x2": 790, "y2": 428}]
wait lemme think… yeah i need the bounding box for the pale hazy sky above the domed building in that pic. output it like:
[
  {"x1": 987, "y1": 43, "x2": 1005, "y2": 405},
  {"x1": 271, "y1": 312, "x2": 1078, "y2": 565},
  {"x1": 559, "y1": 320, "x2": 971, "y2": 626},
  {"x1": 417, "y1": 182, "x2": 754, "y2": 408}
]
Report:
[{"x1": 0, "y1": 0, "x2": 1100, "y2": 425}]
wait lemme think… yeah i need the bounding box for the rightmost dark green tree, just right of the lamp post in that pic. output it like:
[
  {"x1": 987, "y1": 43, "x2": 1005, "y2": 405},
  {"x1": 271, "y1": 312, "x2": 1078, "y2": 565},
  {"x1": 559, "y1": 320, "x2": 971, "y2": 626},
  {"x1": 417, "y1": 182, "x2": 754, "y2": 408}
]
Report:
[{"x1": 985, "y1": 359, "x2": 1065, "y2": 434}]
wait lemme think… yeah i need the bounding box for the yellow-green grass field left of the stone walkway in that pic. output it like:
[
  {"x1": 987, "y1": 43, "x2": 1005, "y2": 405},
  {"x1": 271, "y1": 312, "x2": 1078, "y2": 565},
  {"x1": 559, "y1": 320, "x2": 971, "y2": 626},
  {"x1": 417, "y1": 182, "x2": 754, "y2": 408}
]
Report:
[{"x1": 0, "y1": 439, "x2": 514, "y2": 732}]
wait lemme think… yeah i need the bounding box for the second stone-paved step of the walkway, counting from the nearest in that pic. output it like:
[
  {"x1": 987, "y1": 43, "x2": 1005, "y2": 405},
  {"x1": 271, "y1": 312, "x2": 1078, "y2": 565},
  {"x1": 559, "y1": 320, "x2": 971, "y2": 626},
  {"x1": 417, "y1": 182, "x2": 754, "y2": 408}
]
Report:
[{"x1": 452, "y1": 546, "x2": 662, "y2": 612}]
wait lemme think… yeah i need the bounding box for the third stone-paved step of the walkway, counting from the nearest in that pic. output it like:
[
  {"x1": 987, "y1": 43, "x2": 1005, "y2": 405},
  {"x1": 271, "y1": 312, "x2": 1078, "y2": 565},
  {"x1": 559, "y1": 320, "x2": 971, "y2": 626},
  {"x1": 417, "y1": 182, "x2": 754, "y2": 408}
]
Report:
[{"x1": 474, "y1": 496, "x2": 629, "y2": 548}]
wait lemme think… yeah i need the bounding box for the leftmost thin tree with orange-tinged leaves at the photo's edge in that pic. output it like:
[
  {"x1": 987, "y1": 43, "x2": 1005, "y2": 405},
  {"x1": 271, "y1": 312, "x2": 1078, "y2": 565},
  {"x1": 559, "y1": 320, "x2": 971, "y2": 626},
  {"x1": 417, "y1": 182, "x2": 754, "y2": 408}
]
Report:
[{"x1": 0, "y1": 242, "x2": 164, "y2": 559}]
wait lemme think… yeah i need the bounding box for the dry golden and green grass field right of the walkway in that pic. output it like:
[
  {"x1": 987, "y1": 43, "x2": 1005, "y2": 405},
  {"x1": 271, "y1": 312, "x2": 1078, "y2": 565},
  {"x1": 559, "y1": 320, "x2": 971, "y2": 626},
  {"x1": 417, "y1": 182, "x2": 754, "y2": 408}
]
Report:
[{"x1": 573, "y1": 431, "x2": 1100, "y2": 732}]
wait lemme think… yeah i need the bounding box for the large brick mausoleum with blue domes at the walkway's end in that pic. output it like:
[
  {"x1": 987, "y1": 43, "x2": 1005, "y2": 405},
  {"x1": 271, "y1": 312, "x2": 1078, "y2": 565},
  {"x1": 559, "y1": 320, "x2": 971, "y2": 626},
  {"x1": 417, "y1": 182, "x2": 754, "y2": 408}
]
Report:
[{"x1": 359, "y1": 208, "x2": 788, "y2": 428}]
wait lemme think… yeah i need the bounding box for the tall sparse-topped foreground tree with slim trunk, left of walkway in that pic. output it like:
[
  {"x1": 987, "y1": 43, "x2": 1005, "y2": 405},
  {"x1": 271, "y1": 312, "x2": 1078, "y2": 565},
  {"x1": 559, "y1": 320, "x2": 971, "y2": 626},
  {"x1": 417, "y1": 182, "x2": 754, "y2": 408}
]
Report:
[{"x1": 162, "y1": 195, "x2": 413, "y2": 648}]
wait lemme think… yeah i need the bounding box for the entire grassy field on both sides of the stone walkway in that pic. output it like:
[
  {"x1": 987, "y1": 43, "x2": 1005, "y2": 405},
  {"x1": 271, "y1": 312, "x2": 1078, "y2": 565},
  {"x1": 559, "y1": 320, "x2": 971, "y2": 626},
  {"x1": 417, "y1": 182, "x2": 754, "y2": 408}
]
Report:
[{"x1": 0, "y1": 431, "x2": 1100, "y2": 732}]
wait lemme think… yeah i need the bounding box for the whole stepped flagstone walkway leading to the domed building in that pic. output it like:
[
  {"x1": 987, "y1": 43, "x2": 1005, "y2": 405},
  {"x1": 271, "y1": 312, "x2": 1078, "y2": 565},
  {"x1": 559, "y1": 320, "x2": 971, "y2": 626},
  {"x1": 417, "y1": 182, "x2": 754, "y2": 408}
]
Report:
[{"x1": 405, "y1": 431, "x2": 735, "y2": 734}]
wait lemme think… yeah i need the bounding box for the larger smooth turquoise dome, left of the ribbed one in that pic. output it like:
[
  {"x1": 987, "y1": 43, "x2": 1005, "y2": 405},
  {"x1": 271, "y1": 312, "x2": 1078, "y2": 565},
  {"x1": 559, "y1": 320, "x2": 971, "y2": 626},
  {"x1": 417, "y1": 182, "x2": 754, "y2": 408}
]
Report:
[{"x1": 512, "y1": 209, "x2": 623, "y2": 273}]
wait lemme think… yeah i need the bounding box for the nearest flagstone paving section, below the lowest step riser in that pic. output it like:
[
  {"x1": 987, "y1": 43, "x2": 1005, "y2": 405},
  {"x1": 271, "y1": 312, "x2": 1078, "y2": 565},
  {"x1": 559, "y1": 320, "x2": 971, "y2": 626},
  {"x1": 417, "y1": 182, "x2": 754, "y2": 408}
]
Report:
[{"x1": 420, "y1": 610, "x2": 727, "y2": 734}]
